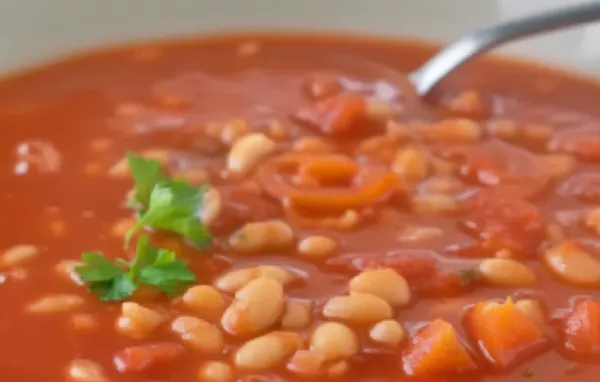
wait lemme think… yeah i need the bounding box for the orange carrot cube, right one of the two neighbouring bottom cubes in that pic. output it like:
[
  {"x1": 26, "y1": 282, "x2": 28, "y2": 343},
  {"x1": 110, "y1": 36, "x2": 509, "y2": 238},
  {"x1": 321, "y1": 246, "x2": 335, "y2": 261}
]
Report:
[{"x1": 465, "y1": 298, "x2": 550, "y2": 369}]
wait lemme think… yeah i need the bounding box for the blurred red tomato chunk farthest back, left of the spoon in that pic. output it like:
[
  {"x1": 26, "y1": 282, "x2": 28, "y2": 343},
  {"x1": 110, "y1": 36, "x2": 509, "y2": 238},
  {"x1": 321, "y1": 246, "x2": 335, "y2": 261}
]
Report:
[{"x1": 294, "y1": 94, "x2": 367, "y2": 136}]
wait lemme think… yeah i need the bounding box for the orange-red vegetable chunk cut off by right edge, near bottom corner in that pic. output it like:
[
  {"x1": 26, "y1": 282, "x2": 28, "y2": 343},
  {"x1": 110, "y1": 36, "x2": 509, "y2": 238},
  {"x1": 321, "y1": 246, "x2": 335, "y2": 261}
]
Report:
[{"x1": 564, "y1": 299, "x2": 600, "y2": 356}]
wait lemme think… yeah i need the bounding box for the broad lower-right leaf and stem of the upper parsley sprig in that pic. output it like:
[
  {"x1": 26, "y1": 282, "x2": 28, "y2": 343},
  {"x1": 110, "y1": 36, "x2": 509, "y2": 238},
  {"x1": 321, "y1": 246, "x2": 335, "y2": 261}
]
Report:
[{"x1": 125, "y1": 180, "x2": 211, "y2": 247}]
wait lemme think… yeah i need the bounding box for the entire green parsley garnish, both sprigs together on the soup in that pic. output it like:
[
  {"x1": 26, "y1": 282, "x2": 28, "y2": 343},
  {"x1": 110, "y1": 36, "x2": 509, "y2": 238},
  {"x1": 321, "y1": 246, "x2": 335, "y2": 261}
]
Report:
[{"x1": 75, "y1": 154, "x2": 211, "y2": 301}]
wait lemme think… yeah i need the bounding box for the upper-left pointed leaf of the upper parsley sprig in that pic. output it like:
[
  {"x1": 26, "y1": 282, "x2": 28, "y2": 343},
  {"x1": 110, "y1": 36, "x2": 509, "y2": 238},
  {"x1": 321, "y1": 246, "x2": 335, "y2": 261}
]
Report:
[{"x1": 127, "y1": 153, "x2": 169, "y2": 211}]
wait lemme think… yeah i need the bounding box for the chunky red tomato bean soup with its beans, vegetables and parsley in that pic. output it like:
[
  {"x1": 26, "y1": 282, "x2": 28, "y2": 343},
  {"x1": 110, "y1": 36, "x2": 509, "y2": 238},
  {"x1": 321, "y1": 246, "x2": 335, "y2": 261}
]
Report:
[{"x1": 0, "y1": 35, "x2": 600, "y2": 382}]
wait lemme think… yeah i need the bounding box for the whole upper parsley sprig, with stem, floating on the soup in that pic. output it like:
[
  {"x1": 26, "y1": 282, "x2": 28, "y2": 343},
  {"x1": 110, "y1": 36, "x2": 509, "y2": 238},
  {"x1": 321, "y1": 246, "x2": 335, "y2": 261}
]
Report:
[{"x1": 125, "y1": 154, "x2": 211, "y2": 247}]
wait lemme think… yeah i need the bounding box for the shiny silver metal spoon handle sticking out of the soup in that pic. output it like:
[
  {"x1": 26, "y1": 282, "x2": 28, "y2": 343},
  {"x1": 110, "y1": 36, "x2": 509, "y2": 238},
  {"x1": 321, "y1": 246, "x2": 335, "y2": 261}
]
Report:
[{"x1": 410, "y1": 1, "x2": 600, "y2": 96}]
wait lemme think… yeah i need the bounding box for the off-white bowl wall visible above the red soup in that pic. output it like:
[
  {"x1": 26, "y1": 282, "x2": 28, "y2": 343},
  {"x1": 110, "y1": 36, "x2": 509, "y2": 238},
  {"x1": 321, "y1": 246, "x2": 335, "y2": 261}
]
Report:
[{"x1": 0, "y1": 0, "x2": 600, "y2": 73}]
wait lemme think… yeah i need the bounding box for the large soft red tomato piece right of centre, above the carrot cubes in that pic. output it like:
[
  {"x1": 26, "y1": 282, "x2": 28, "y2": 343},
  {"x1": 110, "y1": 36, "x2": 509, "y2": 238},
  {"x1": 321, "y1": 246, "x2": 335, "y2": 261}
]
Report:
[{"x1": 462, "y1": 190, "x2": 546, "y2": 256}]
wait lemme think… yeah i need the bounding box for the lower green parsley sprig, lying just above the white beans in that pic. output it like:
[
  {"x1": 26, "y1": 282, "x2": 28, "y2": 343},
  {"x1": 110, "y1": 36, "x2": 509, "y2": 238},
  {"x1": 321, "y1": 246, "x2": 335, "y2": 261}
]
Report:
[{"x1": 75, "y1": 236, "x2": 196, "y2": 301}]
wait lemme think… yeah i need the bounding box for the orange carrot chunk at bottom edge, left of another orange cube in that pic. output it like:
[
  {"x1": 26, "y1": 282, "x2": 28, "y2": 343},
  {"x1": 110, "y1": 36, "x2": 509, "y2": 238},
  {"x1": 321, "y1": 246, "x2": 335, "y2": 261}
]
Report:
[{"x1": 403, "y1": 320, "x2": 477, "y2": 376}]
